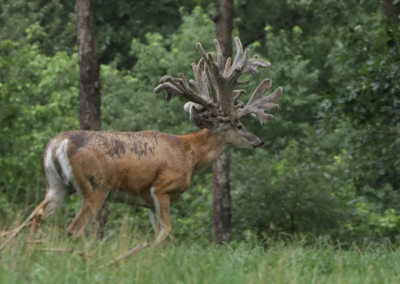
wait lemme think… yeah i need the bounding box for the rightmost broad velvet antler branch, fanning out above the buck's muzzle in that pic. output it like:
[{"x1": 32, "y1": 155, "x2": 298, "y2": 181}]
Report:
[{"x1": 235, "y1": 79, "x2": 282, "y2": 125}]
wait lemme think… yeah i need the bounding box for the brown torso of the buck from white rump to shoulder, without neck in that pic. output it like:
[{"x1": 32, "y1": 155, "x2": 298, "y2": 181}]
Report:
[{"x1": 45, "y1": 131, "x2": 197, "y2": 204}]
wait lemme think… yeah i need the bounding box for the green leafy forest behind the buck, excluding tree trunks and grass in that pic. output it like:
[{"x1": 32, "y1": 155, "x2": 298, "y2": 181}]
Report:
[{"x1": 0, "y1": 0, "x2": 400, "y2": 244}]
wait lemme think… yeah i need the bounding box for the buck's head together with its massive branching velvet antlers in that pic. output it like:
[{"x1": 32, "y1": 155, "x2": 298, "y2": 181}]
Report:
[{"x1": 154, "y1": 37, "x2": 282, "y2": 148}]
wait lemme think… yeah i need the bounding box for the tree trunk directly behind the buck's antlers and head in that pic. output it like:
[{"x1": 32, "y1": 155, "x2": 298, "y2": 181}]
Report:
[{"x1": 212, "y1": 0, "x2": 234, "y2": 244}]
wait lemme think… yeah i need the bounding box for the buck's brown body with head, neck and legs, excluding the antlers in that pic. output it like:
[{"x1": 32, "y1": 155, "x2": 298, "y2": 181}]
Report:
[{"x1": 14, "y1": 123, "x2": 262, "y2": 243}]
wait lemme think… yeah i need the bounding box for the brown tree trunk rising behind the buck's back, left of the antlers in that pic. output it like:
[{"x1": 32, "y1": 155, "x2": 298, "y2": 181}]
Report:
[{"x1": 75, "y1": 0, "x2": 108, "y2": 238}]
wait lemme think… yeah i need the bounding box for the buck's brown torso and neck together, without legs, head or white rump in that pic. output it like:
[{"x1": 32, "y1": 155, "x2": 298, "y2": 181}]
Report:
[{"x1": 54, "y1": 130, "x2": 225, "y2": 202}]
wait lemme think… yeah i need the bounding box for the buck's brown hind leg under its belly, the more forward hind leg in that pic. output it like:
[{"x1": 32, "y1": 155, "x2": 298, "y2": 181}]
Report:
[{"x1": 67, "y1": 189, "x2": 109, "y2": 238}]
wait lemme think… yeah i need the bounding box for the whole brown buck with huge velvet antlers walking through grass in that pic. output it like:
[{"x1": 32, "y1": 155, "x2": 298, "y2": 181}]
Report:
[{"x1": 0, "y1": 38, "x2": 282, "y2": 250}]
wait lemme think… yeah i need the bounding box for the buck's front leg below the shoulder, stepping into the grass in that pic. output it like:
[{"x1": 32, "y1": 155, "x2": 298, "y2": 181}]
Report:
[{"x1": 150, "y1": 187, "x2": 172, "y2": 244}]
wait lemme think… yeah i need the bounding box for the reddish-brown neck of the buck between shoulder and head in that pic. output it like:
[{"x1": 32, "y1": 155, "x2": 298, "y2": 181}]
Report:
[{"x1": 185, "y1": 129, "x2": 227, "y2": 175}]
